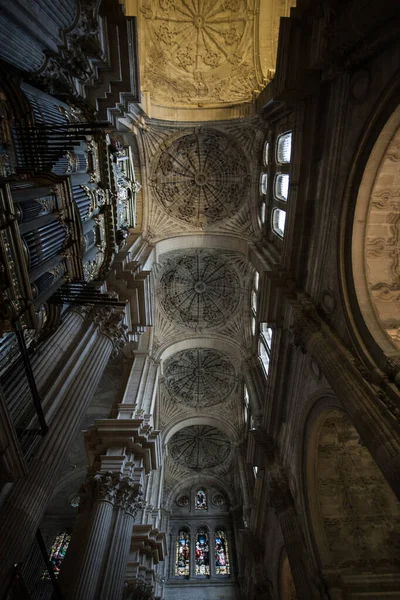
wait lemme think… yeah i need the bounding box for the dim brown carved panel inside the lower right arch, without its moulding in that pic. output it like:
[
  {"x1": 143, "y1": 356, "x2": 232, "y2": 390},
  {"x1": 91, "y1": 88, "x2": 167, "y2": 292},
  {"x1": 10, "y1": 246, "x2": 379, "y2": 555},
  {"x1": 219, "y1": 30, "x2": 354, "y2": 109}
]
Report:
[{"x1": 316, "y1": 411, "x2": 400, "y2": 575}]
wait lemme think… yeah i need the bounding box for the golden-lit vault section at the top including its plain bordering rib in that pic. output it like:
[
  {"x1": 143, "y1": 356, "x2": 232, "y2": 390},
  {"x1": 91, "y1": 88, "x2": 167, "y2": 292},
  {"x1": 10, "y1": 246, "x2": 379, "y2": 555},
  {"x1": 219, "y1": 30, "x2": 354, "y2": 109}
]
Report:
[{"x1": 133, "y1": 0, "x2": 293, "y2": 120}]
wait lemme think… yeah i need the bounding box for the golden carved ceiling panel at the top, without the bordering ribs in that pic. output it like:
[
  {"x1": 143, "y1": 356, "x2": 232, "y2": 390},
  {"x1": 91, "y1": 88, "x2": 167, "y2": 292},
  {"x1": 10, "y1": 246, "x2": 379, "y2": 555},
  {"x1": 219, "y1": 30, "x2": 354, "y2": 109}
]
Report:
[{"x1": 139, "y1": 0, "x2": 263, "y2": 117}]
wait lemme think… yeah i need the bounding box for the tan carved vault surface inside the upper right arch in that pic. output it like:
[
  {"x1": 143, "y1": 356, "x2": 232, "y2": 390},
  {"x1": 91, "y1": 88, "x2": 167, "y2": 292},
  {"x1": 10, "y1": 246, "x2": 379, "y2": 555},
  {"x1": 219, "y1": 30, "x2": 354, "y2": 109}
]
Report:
[{"x1": 352, "y1": 106, "x2": 400, "y2": 356}]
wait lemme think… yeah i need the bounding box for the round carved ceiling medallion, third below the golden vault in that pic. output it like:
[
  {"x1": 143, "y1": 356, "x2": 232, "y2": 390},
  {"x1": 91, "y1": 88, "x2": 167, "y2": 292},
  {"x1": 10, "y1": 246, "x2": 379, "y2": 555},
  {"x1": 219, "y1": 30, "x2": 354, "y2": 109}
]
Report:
[{"x1": 164, "y1": 348, "x2": 235, "y2": 408}]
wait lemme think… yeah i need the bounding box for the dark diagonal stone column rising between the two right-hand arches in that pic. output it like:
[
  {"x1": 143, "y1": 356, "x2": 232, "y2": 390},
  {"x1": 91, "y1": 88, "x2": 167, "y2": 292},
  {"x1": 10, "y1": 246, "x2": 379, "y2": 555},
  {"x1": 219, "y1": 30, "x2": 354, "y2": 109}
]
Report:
[{"x1": 292, "y1": 302, "x2": 400, "y2": 499}]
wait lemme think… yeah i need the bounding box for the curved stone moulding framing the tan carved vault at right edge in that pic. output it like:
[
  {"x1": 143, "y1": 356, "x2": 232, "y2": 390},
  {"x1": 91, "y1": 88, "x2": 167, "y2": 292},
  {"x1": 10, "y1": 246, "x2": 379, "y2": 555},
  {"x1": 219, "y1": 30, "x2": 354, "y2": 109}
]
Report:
[{"x1": 338, "y1": 78, "x2": 399, "y2": 372}]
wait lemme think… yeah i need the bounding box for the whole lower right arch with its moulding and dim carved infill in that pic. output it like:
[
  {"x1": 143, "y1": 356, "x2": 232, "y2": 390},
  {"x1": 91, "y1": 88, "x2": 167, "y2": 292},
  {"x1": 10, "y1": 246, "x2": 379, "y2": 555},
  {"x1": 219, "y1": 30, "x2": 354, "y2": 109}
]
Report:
[{"x1": 305, "y1": 407, "x2": 400, "y2": 598}]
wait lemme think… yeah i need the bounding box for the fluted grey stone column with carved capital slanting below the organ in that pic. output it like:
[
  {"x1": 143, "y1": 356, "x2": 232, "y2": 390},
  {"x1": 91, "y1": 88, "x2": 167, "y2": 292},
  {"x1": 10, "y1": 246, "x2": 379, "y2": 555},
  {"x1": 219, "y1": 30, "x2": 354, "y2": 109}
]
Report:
[{"x1": 0, "y1": 313, "x2": 124, "y2": 597}]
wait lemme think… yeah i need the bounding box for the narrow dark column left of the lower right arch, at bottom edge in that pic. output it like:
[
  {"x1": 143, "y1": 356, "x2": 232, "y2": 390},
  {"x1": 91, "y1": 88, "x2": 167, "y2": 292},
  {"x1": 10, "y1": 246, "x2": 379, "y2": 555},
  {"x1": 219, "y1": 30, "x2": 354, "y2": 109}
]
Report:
[{"x1": 269, "y1": 466, "x2": 320, "y2": 600}]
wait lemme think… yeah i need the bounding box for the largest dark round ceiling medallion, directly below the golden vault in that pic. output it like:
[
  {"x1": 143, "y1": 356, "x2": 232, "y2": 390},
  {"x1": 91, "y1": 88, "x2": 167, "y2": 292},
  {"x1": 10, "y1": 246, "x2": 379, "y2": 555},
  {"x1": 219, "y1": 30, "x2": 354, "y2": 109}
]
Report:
[{"x1": 152, "y1": 128, "x2": 250, "y2": 228}]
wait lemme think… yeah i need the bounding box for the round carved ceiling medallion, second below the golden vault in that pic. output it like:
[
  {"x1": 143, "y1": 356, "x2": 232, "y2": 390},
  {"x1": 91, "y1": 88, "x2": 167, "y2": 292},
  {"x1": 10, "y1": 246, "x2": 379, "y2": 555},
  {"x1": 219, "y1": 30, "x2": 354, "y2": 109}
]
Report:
[{"x1": 158, "y1": 249, "x2": 240, "y2": 331}]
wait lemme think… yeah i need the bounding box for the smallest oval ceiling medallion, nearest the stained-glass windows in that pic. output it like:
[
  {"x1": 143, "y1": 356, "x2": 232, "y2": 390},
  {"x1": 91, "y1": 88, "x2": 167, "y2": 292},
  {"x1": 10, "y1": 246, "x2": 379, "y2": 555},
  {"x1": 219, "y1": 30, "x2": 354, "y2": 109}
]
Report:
[{"x1": 168, "y1": 425, "x2": 231, "y2": 471}]
